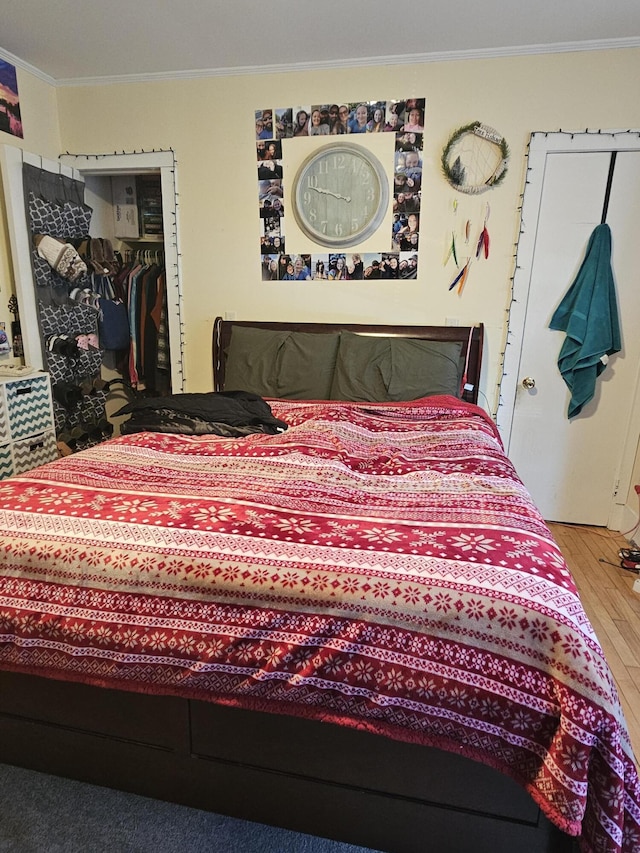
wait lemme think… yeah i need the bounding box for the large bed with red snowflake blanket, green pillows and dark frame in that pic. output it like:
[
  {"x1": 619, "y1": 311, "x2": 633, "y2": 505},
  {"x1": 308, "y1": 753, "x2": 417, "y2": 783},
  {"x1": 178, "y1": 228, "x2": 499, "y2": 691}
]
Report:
[{"x1": 0, "y1": 318, "x2": 640, "y2": 853}]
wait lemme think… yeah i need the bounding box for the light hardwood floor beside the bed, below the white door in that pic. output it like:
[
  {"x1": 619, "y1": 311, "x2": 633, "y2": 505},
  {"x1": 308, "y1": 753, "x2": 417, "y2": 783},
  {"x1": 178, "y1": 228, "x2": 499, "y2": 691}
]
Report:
[{"x1": 549, "y1": 523, "x2": 640, "y2": 765}]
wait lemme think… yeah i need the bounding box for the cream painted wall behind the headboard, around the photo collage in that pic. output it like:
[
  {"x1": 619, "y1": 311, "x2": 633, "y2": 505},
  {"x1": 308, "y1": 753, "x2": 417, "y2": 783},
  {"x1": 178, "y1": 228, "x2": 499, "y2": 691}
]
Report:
[{"x1": 0, "y1": 49, "x2": 640, "y2": 524}]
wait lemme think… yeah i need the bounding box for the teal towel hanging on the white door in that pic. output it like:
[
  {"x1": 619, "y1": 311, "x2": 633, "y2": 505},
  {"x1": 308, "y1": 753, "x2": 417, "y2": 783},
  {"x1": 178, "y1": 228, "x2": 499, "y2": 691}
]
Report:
[{"x1": 549, "y1": 223, "x2": 621, "y2": 418}]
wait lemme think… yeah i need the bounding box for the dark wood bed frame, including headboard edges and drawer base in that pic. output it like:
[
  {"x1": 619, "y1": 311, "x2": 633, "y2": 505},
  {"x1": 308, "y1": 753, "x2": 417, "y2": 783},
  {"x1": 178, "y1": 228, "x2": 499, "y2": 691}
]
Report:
[{"x1": 0, "y1": 321, "x2": 574, "y2": 853}]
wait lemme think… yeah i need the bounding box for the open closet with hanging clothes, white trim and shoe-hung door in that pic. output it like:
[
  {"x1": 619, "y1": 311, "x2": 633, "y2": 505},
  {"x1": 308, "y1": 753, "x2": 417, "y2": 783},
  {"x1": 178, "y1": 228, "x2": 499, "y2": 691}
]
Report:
[{"x1": 0, "y1": 146, "x2": 184, "y2": 449}]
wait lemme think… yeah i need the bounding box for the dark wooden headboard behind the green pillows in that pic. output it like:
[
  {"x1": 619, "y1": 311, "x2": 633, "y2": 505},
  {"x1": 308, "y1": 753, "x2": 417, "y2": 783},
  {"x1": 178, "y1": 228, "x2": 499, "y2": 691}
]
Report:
[{"x1": 213, "y1": 317, "x2": 484, "y2": 403}]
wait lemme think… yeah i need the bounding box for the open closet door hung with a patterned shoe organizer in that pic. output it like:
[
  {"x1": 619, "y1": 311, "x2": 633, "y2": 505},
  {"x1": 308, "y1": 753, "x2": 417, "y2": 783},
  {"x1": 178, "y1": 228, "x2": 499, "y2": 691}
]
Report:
[{"x1": 0, "y1": 145, "x2": 111, "y2": 449}]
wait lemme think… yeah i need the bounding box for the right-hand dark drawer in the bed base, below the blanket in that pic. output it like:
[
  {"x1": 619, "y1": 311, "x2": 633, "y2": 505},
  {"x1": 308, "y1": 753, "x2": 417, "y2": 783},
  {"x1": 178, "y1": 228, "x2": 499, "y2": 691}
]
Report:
[{"x1": 191, "y1": 702, "x2": 539, "y2": 824}]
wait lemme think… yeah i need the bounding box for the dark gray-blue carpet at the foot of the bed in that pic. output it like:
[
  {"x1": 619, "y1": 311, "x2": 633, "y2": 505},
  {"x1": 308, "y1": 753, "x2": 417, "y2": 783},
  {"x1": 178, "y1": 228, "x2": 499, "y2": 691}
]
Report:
[{"x1": 0, "y1": 764, "x2": 378, "y2": 853}]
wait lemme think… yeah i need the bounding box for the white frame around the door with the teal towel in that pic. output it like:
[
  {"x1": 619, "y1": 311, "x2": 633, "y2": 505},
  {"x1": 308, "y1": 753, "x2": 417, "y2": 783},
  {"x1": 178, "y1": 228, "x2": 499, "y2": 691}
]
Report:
[{"x1": 497, "y1": 130, "x2": 640, "y2": 530}]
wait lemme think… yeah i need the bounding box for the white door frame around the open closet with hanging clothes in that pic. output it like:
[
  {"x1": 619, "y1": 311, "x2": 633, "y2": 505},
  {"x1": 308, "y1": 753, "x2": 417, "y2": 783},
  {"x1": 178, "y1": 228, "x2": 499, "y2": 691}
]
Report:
[{"x1": 0, "y1": 145, "x2": 185, "y2": 393}]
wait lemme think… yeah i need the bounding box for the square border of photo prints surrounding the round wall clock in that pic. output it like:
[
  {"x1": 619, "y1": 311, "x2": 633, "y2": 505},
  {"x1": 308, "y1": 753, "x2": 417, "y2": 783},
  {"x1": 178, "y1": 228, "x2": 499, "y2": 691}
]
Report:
[{"x1": 255, "y1": 98, "x2": 426, "y2": 281}]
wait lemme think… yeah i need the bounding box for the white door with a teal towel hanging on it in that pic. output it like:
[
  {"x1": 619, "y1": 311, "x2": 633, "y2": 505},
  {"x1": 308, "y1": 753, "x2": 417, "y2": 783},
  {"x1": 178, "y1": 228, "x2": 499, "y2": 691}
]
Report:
[{"x1": 508, "y1": 143, "x2": 640, "y2": 526}]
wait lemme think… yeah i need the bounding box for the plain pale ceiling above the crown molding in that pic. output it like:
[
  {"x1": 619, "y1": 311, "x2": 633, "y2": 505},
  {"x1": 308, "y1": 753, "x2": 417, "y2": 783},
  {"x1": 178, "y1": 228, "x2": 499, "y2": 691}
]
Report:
[{"x1": 0, "y1": 0, "x2": 640, "y2": 85}]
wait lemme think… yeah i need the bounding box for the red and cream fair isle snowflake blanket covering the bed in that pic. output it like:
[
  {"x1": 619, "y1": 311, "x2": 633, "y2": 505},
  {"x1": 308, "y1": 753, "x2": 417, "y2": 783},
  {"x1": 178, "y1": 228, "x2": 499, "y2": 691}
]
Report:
[{"x1": 0, "y1": 397, "x2": 640, "y2": 853}]
